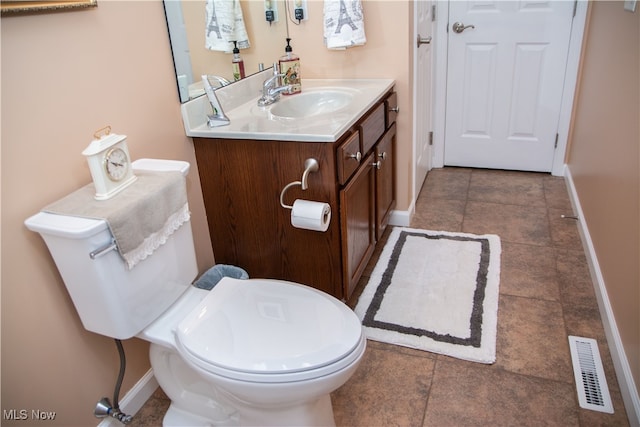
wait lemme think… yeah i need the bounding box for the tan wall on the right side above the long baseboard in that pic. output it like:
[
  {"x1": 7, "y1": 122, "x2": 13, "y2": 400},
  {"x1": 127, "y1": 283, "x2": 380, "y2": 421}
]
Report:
[{"x1": 568, "y1": 1, "x2": 640, "y2": 402}]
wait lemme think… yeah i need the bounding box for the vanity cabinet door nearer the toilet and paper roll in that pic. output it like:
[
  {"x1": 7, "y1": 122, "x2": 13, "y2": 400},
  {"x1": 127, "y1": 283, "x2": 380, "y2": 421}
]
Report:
[{"x1": 340, "y1": 153, "x2": 376, "y2": 300}]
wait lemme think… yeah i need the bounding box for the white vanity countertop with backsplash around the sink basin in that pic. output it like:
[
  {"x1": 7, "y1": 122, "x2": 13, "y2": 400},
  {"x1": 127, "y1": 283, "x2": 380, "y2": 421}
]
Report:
[{"x1": 182, "y1": 75, "x2": 395, "y2": 142}]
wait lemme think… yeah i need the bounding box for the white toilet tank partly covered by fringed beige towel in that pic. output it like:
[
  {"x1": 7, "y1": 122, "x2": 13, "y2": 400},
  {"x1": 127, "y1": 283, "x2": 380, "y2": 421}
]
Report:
[{"x1": 25, "y1": 159, "x2": 198, "y2": 339}]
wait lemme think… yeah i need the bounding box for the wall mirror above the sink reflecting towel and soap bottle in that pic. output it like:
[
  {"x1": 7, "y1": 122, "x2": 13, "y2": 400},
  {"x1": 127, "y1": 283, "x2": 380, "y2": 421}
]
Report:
[{"x1": 164, "y1": 0, "x2": 287, "y2": 103}]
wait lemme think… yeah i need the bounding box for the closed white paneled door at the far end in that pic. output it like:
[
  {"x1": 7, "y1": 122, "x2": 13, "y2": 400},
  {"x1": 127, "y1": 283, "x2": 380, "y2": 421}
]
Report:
[{"x1": 444, "y1": 0, "x2": 574, "y2": 172}]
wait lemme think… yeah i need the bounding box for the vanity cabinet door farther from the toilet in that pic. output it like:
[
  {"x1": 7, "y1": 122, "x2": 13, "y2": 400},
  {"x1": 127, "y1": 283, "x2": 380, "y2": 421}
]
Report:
[{"x1": 374, "y1": 123, "x2": 396, "y2": 240}]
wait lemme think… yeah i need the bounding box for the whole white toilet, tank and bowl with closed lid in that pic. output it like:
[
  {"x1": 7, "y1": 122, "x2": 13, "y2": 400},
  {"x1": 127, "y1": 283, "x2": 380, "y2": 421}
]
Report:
[{"x1": 25, "y1": 159, "x2": 366, "y2": 426}]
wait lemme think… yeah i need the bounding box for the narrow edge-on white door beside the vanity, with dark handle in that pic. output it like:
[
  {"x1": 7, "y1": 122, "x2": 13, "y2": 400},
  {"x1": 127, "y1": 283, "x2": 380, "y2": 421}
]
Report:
[{"x1": 413, "y1": 0, "x2": 433, "y2": 200}]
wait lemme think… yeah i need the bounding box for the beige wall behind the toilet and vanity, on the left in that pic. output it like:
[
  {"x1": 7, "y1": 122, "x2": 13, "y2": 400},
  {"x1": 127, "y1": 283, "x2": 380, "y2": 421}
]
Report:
[{"x1": 1, "y1": 0, "x2": 412, "y2": 426}]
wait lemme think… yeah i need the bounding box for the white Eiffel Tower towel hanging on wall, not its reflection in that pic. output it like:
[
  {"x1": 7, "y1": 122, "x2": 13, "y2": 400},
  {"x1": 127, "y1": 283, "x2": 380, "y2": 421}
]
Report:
[{"x1": 324, "y1": 0, "x2": 367, "y2": 49}]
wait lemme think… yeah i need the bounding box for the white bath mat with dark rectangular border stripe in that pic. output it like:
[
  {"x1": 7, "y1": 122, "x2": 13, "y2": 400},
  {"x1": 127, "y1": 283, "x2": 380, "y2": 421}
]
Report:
[{"x1": 355, "y1": 227, "x2": 501, "y2": 363}]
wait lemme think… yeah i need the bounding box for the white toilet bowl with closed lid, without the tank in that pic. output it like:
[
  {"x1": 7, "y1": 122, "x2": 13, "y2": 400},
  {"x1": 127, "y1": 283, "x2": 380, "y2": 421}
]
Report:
[{"x1": 138, "y1": 277, "x2": 366, "y2": 426}]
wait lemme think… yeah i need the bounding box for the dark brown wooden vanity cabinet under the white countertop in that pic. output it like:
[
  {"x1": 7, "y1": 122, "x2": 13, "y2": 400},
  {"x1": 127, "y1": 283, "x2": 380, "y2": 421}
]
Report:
[{"x1": 193, "y1": 92, "x2": 396, "y2": 300}]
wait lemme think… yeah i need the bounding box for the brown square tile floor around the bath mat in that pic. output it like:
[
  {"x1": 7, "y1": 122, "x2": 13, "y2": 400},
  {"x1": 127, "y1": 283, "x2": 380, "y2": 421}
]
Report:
[{"x1": 129, "y1": 168, "x2": 628, "y2": 427}]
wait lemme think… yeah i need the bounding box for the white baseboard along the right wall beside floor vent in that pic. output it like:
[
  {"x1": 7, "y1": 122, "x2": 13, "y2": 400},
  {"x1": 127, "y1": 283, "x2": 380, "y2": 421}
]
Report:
[{"x1": 564, "y1": 165, "x2": 640, "y2": 427}]
